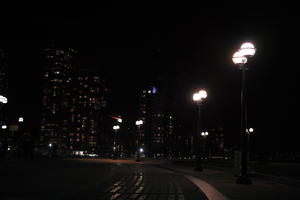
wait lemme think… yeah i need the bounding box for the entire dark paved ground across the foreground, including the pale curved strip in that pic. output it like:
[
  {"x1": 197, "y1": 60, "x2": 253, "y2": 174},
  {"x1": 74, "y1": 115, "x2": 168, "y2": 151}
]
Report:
[{"x1": 0, "y1": 158, "x2": 300, "y2": 200}]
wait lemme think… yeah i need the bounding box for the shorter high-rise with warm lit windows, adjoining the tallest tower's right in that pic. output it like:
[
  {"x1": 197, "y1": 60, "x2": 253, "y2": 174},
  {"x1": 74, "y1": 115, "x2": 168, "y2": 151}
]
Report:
[{"x1": 65, "y1": 69, "x2": 108, "y2": 153}]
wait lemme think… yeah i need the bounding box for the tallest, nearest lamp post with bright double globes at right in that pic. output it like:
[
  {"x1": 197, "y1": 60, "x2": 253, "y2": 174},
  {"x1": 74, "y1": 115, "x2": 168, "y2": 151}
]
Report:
[{"x1": 232, "y1": 42, "x2": 256, "y2": 184}]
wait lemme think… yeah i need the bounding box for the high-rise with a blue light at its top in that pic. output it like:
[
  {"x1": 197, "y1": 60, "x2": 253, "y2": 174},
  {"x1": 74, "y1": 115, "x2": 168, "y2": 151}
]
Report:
[{"x1": 139, "y1": 86, "x2": 174, "y2": 157}]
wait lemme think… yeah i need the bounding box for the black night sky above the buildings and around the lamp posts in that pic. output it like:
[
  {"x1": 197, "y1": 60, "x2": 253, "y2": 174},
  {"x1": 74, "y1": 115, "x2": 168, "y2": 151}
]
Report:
[{"x1": 0, "y1": 4, "x2": 299, "y2": 152}]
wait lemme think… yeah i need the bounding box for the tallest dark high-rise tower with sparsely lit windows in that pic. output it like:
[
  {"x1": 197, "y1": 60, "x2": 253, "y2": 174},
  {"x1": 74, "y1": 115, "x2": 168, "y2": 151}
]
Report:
[{"x1": 40, "y1": 46, "x2": 77, "y2": 152}]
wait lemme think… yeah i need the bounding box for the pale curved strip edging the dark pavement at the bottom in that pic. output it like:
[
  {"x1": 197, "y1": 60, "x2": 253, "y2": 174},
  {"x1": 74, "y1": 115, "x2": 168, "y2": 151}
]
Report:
[{"x1": 184, "y1": 175, "x2": 229, "y2": 200}]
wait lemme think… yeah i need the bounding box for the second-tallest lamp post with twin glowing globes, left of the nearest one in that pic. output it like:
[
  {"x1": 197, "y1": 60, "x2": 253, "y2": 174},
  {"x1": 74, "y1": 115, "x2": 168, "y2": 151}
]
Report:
[{"x1": 193, "y1": 90, "x2": 207, "y2": 171}]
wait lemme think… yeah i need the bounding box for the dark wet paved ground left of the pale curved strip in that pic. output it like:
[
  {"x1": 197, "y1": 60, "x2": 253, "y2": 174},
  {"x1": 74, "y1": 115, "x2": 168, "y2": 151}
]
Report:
[{"x1": 0, "y1": 159, "x2": 207, "y2": 200}]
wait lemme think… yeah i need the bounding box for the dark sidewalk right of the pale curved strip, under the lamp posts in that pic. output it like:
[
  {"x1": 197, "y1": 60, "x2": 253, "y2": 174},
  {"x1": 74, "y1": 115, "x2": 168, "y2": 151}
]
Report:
[{"x1": 141, "y1": 160, "x2": 300, "y2": 200}]
